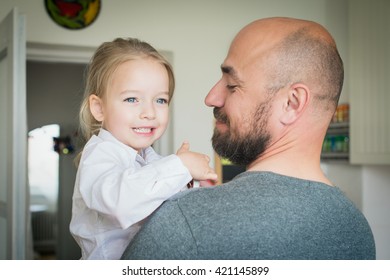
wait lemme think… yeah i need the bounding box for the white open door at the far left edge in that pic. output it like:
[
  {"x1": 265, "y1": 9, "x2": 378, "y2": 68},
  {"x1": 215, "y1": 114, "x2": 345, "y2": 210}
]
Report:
[{"x1": 0, "y1": 8, "x2": 28, "y2": 260}]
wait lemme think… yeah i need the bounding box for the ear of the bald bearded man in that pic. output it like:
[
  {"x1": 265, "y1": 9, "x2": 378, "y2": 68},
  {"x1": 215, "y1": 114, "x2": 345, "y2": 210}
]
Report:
[{"x1": 281, "y1": 84, "x2": 310, "y2": 124}]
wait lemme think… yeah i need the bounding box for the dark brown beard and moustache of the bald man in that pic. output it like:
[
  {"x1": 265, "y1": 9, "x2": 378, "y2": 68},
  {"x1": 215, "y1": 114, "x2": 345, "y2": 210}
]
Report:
[{"x1": 211, "y1": 101, "x2": 271, "y2": 166}]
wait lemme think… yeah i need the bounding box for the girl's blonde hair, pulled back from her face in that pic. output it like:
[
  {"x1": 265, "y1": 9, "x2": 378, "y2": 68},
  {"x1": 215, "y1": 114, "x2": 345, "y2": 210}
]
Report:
[{"x1": 76, "y1": 38, "x2": 175, "y2": 164}]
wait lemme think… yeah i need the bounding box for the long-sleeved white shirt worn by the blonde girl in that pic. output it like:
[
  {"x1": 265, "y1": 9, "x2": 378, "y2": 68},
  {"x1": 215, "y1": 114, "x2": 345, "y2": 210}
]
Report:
[{"x1": 70, "y1": 129, "x2": 192, "y2": 259}]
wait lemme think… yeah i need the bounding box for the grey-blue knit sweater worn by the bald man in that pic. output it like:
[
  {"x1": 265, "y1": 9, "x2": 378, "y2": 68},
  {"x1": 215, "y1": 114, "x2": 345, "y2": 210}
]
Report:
[{"x1": 122, "y1": 172, "x2": 375, "y2": 260}]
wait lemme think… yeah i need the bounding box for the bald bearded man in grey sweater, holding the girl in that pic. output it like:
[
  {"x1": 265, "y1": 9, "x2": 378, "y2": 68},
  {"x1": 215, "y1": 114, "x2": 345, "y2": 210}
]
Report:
[{"x1": 122, "y1": 18, "x2": 375, "y2": 260}]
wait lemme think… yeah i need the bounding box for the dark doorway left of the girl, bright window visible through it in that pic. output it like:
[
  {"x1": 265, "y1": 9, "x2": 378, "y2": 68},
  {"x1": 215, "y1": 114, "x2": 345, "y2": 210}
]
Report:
[{"x1": 26, "y1": 60, "x2": 86, "y2": 260}]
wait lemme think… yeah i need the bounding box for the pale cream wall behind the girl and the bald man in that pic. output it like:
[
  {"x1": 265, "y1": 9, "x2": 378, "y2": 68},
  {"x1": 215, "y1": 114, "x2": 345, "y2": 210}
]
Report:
[{"x1": 0, "y1": 0, "x2": 390, "y2": 259}]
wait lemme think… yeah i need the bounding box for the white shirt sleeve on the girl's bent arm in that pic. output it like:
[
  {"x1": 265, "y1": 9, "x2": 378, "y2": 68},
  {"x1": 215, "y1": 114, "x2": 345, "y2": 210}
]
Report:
[{"x1": 79, "y1": 142, "x2": 192, "y2": 228}]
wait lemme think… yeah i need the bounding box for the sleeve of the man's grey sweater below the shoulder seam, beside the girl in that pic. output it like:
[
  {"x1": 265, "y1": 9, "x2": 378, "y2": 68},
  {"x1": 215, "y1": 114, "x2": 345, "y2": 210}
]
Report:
[{"x1": 122, "y1": 200, "x2": 198, "y2": 260}]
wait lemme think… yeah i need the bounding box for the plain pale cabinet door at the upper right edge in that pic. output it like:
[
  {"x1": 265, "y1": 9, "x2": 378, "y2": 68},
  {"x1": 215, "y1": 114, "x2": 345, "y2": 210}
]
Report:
[{"x1": 347, "y1": 0, "x2": 390, "y2": 164}]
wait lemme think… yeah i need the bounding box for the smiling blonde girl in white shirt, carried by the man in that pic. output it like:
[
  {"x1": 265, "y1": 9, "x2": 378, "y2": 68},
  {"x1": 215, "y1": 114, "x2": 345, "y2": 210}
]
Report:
[{"x1": 70, "y1": 38, "x2": 217, "y2": 259}]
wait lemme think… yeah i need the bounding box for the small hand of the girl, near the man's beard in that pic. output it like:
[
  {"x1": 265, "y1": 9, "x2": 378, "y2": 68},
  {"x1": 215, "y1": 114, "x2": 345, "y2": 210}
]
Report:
[{"x1": 176, "y1": 142, "x2": 218, "y2": 181}]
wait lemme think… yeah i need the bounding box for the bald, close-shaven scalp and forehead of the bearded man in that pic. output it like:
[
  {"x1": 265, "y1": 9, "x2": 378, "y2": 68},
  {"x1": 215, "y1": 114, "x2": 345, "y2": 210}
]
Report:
[{"x1": 229, "y1": 17, "x2": 344, "y2": 112}]
